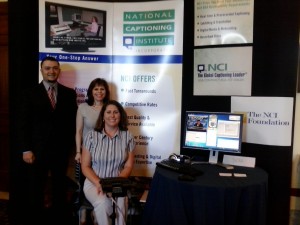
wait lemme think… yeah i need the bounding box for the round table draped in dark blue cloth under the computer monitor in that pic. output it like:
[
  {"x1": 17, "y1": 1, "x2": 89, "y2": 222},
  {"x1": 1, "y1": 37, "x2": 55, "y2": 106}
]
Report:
[{"x1": 142, "y1": 164, "x2": 268, "y2": 225}]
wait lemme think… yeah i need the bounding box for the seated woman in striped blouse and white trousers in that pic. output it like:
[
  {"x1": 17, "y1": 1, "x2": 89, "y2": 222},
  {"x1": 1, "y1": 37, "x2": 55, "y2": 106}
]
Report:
[{"x1": 81, "y1": 100, "x2": 135, "y2": 225}]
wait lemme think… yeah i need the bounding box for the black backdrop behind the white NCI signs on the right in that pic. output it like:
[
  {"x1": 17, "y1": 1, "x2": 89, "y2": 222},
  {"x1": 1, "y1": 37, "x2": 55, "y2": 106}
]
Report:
[{"x1": 182, "y1": 0, "x2": 300, "y2": 225}]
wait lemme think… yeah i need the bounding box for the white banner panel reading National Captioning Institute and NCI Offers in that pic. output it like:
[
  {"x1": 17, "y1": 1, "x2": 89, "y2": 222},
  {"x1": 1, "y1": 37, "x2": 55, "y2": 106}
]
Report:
[{"x1": 113, "y1": 1, "x2": 183, "y2": 176}]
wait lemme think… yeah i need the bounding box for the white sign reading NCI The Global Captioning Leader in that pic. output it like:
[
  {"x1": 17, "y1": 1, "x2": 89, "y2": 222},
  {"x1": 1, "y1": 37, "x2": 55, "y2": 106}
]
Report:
[{"x1": 193, "y1": 47, "x2": 252, "y2": 96}]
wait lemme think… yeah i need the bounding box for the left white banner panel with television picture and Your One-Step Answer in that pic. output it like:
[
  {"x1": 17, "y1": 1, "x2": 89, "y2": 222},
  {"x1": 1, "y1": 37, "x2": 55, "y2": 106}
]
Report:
[{"x1": 39, "y1": 0, "x2": 113, "y2": 104}]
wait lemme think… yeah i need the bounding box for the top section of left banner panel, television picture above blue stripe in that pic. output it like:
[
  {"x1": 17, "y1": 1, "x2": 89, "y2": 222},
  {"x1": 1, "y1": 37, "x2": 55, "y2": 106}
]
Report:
[{"x1": 39, "y1": 0, "x2": 113, "y2": 54}]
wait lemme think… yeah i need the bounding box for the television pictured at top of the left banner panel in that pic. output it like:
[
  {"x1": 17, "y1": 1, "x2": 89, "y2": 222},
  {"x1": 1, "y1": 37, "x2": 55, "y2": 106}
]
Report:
[{"x1": 45, "y1": 2, "x2": 106, "y2": 52}]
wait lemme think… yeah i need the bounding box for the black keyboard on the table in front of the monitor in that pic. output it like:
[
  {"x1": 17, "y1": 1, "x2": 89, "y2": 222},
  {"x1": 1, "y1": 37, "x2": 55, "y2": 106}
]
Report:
[{"x1": 156, "y1": 159, "x2": 203, "y2": 176}]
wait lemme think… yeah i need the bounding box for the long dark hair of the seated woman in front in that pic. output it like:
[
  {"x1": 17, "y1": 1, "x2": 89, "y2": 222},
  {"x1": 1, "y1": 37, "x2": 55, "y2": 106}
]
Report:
[{"x1": 95, "y1": 100, "x2": 128, "y2": 132}]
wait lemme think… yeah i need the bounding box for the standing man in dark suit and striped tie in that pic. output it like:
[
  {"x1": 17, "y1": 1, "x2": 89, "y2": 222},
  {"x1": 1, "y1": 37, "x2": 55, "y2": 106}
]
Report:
[{"x1": 19, "y1": 57, "x2": 77, "y2": 224}]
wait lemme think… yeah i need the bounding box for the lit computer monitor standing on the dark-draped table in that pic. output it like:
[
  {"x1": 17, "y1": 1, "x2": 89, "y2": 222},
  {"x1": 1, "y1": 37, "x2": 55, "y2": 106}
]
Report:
[{"x1": 181, "y1": 111, "x2": 243, "y2": 163}]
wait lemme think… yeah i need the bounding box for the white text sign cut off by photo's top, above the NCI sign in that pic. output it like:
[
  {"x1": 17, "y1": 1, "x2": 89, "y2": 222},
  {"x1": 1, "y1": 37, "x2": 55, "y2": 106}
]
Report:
[{"x1": 194, "y1": 0, "x2": 254, "y2": 46}]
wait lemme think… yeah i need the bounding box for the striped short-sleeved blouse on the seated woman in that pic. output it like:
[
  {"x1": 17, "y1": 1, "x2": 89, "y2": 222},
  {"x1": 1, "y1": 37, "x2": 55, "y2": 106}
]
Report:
[{"x1": 83, "y1": 130, "x2": 135, "y2": 178}]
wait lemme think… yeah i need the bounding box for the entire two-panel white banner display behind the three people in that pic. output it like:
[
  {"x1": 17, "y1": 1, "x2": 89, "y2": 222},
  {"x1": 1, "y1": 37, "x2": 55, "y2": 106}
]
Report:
[{"x1": 39, "y1": 0, "x2": 183, "y2": 176}]
